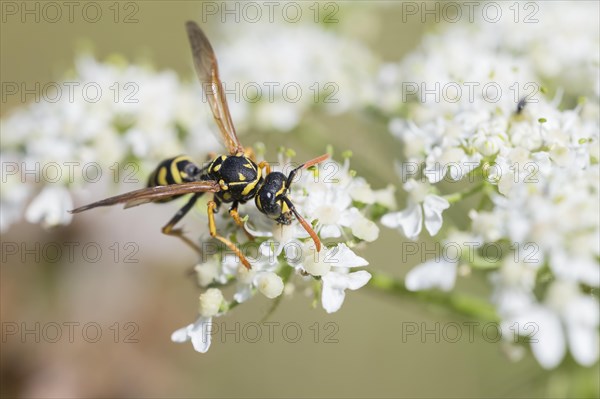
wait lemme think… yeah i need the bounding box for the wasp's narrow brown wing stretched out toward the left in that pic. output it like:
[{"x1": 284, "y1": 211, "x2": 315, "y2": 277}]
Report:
[{"x1": 69, "y1": 180, "x2": 221, "y2": 213}]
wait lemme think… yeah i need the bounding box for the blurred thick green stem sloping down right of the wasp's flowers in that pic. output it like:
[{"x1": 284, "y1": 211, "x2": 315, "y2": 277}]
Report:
[{"x1": 367, "y1": 273, "x2": 500, "y2": 322}]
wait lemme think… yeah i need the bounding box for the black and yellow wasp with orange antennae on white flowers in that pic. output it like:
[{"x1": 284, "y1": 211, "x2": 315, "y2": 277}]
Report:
[{"x1": 71, "y1": 21, "x2": 328, "y2": 269}]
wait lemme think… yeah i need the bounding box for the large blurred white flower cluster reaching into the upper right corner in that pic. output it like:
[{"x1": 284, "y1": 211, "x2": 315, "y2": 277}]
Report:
[{"x1": 372, "y1": 2, "x2": 600, "y2": 123}]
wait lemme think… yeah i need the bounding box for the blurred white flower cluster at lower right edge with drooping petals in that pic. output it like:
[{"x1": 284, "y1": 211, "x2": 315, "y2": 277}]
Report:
[{"x1": 488, "y1": 164, "x2": 600, "y2": 368}]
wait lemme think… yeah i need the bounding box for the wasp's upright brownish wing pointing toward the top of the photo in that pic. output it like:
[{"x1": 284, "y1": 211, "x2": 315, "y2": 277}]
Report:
[{"x1": 185, "y1": 21, "x2": 244, "y2": 155}]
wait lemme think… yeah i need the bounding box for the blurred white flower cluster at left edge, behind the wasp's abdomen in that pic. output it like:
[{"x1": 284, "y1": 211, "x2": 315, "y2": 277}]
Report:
[{"x1": 0, "y1": 56, "x2": 219, "y2": 231}]
